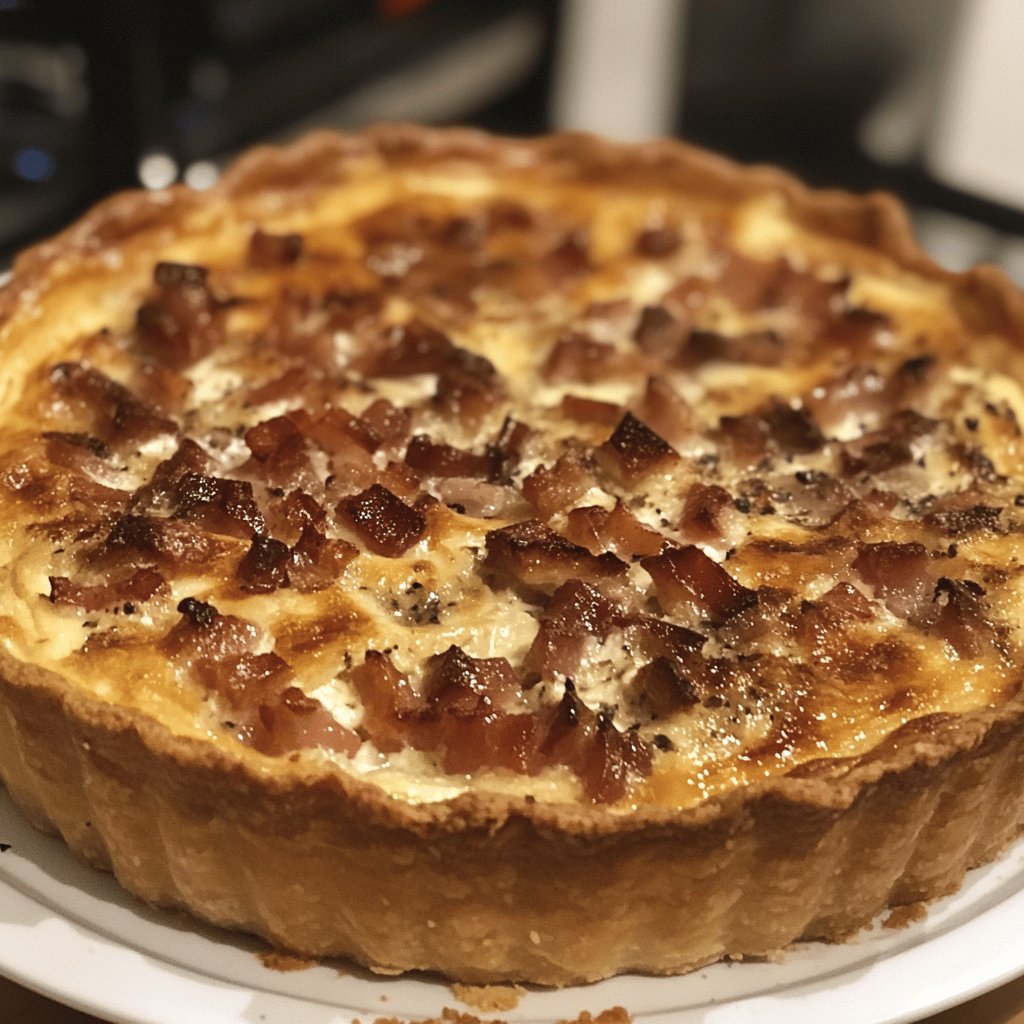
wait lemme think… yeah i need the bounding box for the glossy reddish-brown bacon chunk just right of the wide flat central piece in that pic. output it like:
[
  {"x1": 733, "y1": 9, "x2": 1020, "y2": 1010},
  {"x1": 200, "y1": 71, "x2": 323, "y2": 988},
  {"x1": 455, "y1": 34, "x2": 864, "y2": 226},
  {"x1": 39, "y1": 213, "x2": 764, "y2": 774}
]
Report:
[{"x1": 640, "y1": 544, "x2": 758, "y2": 624}]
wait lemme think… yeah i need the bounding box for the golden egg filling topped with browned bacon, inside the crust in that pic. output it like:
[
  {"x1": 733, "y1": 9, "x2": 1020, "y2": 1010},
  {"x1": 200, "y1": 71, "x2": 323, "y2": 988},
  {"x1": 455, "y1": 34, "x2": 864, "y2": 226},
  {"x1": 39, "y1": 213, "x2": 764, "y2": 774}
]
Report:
[{"x1": 0, "y1": 168, "x2": 1024, "y2": 812}]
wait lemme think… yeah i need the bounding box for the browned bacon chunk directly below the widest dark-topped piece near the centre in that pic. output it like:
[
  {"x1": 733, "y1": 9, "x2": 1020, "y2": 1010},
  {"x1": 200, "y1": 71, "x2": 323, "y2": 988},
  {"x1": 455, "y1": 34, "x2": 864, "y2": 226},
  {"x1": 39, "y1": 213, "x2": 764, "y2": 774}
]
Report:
[{"x1": 523, "y1": 580, "x2": 620, "y2": 687}]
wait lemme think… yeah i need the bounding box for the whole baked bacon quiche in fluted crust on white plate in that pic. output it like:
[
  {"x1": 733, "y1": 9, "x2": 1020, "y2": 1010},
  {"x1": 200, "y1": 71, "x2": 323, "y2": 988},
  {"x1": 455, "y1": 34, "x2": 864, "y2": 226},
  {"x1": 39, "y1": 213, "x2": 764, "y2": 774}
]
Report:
[{"x1": 0, "y1": 126, "x2": 1024, "y2": 985}]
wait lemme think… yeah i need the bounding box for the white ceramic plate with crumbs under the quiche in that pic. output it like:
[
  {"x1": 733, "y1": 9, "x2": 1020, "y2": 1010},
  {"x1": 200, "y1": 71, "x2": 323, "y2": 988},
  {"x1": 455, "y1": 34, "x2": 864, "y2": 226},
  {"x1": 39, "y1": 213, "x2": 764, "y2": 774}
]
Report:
[{"x1": 0, "y1": 790, "x2": 1024, "y2": 1024}]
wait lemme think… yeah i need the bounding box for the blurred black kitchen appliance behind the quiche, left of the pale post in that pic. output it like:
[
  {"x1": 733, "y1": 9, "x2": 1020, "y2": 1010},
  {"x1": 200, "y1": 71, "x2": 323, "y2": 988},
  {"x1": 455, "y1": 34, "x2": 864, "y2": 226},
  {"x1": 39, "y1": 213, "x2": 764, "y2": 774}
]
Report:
[{"x1": 0, "y1": 0, "x2": 559, "y2": 258}]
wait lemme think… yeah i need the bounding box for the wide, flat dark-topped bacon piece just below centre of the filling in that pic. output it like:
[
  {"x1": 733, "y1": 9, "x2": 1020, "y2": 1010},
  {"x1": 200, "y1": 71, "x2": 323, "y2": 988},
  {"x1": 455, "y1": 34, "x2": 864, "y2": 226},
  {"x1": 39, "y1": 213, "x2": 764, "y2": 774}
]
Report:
[{"x1": 484, "y1": 519, "x2": 626, "y2": 591}]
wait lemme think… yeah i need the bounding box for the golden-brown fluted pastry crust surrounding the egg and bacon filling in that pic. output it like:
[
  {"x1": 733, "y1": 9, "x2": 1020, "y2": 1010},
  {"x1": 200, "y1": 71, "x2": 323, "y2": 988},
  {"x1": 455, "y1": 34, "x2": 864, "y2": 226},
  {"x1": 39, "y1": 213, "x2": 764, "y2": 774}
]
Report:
[{"x1": 0, "y1": 126, "x2": 1024, "y2": 985}]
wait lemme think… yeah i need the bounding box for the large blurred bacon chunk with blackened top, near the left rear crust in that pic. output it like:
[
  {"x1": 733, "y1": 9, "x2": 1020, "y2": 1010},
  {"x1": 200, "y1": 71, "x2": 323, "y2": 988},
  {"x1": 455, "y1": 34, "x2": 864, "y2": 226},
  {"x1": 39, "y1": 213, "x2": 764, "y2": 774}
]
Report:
[{"x1": 135, "y1": 263, "x2": 225, "y2": 370}]
